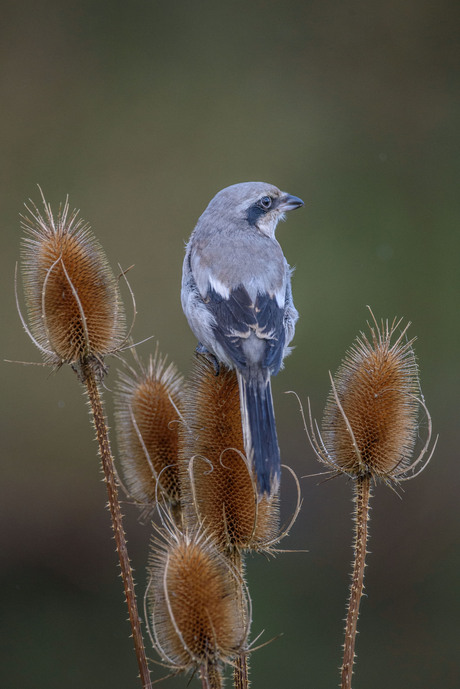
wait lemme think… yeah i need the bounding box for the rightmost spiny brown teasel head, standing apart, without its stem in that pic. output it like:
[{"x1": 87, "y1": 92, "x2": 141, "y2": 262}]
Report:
[{"x1": 310, "y1": 312, "x2": 434, "y2": 481}]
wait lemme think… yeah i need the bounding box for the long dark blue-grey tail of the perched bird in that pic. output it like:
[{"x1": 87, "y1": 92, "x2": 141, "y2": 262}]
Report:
[{"x1": 238, "y1": 371, "x2": 280, "y2": 496}]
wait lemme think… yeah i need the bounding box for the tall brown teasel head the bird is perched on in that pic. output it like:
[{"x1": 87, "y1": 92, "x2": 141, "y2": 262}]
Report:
[{"x1": 180, "y1": 355, "x2": 279, "y2": 550}]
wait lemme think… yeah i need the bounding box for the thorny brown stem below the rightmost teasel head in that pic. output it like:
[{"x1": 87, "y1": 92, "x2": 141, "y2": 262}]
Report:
[{"x1": 341, "y1": 475, "x2": 371, "y2": 689}]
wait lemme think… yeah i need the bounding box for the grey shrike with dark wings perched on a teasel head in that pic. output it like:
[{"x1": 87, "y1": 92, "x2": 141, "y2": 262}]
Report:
[{"x1": 181, "y1": 182, "x2": 303, "y2": 496}]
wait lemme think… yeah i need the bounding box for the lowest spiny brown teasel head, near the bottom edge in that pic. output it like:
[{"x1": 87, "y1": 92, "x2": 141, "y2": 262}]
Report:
[{"x1": 146, "y1": 526, "x2": 251, "y2": 686}]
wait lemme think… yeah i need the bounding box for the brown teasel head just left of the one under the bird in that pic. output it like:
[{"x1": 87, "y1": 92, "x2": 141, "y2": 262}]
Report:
[{"x1": 115, "y1": 348, "x2": 183, "y2": 510}]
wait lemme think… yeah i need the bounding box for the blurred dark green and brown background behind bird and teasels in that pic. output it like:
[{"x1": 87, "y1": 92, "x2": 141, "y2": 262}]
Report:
[{"x1": 0, "y1": 0, "x2": 460, "y2": 689}]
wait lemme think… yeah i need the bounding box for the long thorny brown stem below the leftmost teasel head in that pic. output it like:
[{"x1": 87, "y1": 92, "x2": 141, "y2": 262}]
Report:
[{"x1": 81, "y1": 363, "x2": 152, "y2": 689}]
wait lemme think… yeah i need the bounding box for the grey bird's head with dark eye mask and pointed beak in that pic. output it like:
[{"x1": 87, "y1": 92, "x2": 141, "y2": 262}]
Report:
[{"x1": 203, "y1": 182, "x2": 304, "y2": 237}]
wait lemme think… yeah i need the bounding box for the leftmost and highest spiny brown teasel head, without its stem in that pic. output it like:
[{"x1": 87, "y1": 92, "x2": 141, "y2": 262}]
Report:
[{"x1": 21, "y1": 195, "x2": 125, "y2": 376}]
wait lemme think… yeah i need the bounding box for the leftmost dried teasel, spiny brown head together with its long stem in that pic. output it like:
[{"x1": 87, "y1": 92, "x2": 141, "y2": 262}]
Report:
[{"x1": 17, "y1": 195, "x2": 151, "y2": 689}]
